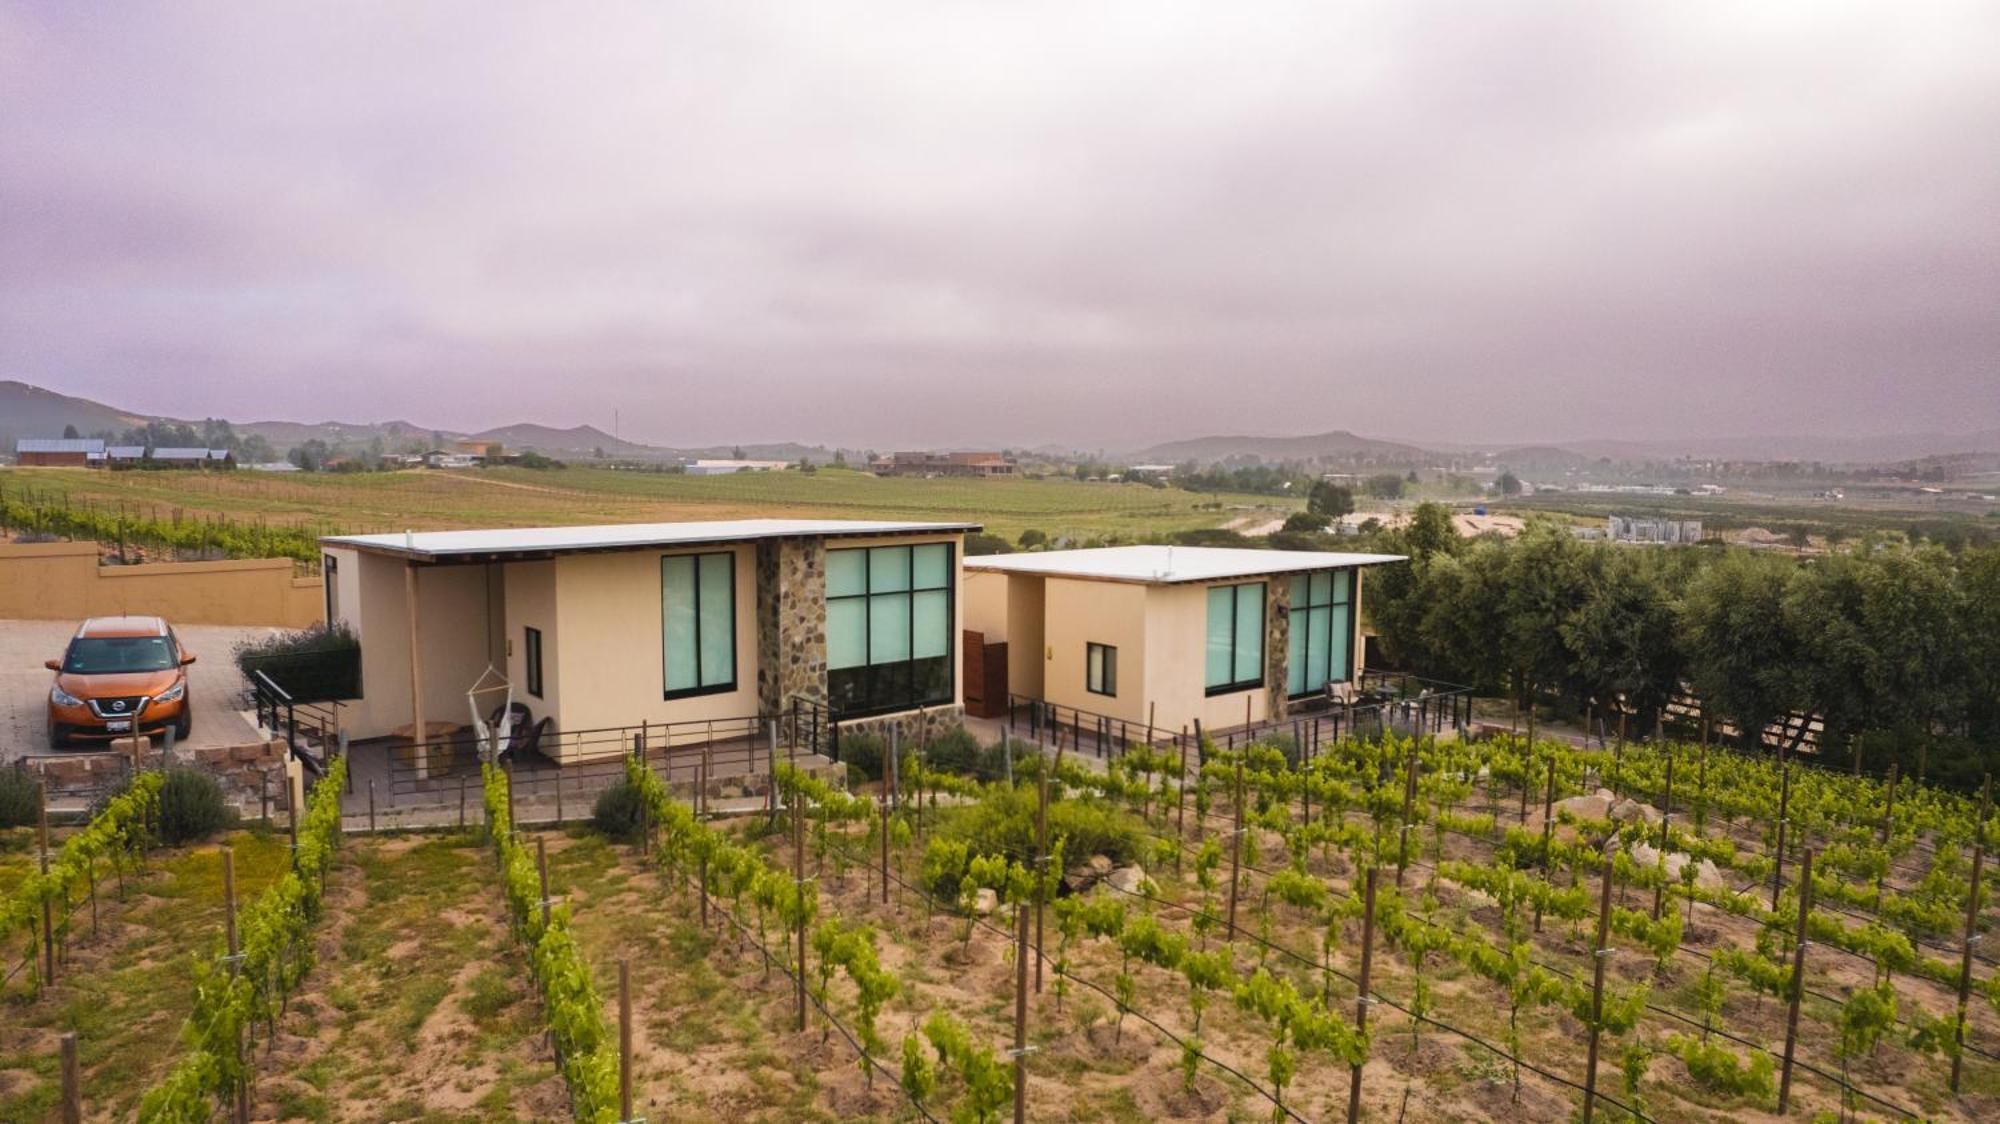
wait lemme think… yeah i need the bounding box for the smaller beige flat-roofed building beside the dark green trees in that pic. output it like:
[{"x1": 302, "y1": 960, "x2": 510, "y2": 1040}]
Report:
[{"x1": 964, "y1": 546, "x2": 1404, "y2": 730}]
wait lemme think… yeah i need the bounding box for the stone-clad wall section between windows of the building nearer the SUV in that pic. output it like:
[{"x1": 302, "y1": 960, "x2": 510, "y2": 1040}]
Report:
[{"x1": 756, "y1": 538, "x2": 826, "y2": 714}]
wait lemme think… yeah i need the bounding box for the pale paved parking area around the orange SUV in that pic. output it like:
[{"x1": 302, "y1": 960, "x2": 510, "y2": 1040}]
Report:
[{"x1": 0, "y1": 620, "x2": 276, "y2": 762}]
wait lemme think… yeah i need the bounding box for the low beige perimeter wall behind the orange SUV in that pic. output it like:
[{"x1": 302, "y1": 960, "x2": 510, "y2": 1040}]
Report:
[{"x1": 0, "y1": 542, "x2": 326, "y2": 628}]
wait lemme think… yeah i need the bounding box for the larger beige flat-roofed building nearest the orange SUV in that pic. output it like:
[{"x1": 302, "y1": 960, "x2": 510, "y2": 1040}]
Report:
[{"x1": 322, "y1": 520, "x2": 978, "y2": 758}]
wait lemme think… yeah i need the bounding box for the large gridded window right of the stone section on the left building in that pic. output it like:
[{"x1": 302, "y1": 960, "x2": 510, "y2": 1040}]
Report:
[{"x1": 826, "y1": 542, "x2": 954, "y2": 716}]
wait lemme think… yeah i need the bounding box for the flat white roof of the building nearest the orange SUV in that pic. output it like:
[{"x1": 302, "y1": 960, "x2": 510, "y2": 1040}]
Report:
[{"x1": 320, "y1": 520, "x2": 980, "y2": 560}]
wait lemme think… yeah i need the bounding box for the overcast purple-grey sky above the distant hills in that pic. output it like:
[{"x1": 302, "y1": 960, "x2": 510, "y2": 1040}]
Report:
[{"x1": 0, "y1": 0, "x2": 2000, "y2": 448}]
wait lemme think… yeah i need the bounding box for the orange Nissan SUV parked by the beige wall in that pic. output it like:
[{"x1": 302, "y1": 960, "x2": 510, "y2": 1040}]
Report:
[{"x1": 46, "y1": 616, "x2": 194, "y2": 748}]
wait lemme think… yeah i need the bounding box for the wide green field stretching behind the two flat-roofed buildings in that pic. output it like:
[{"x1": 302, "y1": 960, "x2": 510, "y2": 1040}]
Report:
[{"x1": 0, "y1": 468, "x2": 1300, "y2": 540}]
